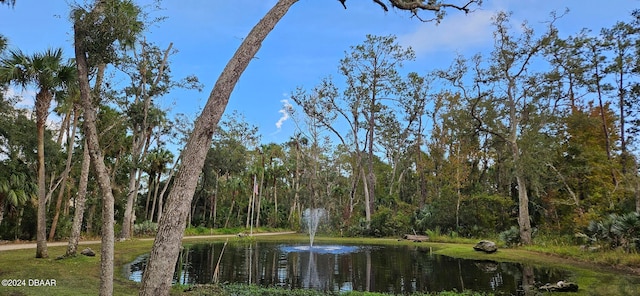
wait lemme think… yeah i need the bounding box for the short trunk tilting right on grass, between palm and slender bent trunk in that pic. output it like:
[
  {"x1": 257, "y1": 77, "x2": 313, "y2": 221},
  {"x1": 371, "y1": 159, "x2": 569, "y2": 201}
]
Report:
[{"x1": 65, "y1": 140, "x2": 91, "y2": 257}]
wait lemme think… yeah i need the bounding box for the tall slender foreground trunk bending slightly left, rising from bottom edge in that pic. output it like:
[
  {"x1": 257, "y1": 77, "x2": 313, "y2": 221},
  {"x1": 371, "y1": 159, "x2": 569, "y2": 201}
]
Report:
[{"x1": 74, "y1": 24, "x2": 115, "y2": 295}]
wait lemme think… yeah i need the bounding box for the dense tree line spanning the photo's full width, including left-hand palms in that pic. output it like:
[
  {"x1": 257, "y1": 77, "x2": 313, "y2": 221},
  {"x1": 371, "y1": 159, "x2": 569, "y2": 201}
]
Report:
[{"x1": 0, "y1": 1, "x2": 640, "y2": 294}]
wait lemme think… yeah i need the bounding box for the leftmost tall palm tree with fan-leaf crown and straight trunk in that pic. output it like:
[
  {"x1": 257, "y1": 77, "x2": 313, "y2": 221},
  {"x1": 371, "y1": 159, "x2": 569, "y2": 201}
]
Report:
[{"x1": 0, "y1": 49, "x2": 75, "y2": 258}]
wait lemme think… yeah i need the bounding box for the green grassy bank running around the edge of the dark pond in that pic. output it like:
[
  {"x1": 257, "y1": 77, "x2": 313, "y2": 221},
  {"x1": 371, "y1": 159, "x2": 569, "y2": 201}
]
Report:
[{"x1": 0, "y1": 233, "x2": 640, "y2": 296}]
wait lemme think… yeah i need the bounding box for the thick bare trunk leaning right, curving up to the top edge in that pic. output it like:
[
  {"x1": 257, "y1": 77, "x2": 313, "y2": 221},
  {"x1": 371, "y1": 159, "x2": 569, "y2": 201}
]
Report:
[{"x1": 140, "y1": 0, "x2": 298, "y2": 296}]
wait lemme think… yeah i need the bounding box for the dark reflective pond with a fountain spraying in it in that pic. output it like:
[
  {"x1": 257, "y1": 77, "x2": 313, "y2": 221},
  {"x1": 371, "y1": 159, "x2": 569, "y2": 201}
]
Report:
[{"x1": 125, "y1": 242, "x2": 571, "y2": 295}]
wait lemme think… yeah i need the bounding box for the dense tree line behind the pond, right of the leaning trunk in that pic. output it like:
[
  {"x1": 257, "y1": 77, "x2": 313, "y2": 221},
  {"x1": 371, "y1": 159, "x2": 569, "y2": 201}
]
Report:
[{"x1": 181, "y1": 14, "x2": 639, "y2": 243}]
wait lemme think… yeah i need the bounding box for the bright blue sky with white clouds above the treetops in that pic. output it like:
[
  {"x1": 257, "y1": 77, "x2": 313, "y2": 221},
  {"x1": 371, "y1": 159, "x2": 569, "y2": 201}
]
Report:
[{"x1": 0, "y1": 0, "x2": 640, "y2": 143}]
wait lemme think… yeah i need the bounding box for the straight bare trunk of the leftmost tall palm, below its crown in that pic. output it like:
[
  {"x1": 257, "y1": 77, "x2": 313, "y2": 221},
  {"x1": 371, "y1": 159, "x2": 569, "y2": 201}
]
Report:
[{"x1": 36, "y1": 92, "x2": 51, "y2": 258}]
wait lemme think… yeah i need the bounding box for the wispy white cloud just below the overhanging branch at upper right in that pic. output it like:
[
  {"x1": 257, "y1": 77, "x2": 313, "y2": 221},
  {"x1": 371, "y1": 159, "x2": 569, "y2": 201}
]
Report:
[{"x1": 398, "y1": 10, "x2": 495, "y2": 56}]
